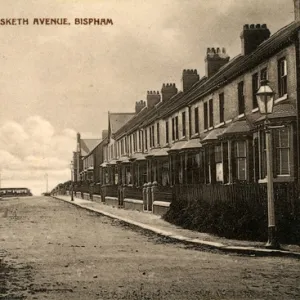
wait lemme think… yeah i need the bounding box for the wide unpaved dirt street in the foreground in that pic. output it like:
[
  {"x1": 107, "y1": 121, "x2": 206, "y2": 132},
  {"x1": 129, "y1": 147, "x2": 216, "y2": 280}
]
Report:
[{"x1": 0, "y1": 197, "x2": 300, "y2": 300}]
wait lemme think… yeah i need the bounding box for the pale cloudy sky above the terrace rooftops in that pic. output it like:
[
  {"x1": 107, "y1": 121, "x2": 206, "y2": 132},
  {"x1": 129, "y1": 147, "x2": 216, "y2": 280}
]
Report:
[{"x1": 0, "y1": 0, "x2": 294, "y2": 194}]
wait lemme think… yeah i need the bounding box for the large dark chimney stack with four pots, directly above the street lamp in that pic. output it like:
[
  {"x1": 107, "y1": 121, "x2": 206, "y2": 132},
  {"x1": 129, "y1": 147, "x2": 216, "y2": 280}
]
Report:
[{"x1": 241, "y1": 24, "x2": 271, "y2": 55}]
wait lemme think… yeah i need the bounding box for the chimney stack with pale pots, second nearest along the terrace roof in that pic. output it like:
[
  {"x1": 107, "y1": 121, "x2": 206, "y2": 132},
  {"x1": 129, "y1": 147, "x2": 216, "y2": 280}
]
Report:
[{"x1": 205, "y1": 48, "x2": 230, "y2": 78}]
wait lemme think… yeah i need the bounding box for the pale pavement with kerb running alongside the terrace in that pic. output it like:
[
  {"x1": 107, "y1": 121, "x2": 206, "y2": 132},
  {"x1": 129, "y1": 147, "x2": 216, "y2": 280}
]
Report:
[{"x1": 53, "y1": 195, "x2": 300, "y2": 259}]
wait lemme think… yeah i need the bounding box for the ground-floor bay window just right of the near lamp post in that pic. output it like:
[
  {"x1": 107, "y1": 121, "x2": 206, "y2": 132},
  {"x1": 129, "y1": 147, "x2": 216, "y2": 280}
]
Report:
[{"x1": 273, "y1": 127, "x2": 291, "y2": 175}]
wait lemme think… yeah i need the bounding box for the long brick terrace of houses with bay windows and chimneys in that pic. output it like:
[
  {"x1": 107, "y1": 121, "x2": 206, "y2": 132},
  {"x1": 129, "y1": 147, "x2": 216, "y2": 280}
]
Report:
[{"x1": 98, "y1": 10, "x2": 300, "y2": 214}]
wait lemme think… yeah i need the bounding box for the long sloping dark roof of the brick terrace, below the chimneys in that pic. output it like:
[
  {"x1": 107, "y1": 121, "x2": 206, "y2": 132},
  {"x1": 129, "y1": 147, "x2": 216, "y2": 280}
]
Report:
[{"x1": 113, "y1": 21, "x2": 300, "y2": 141}]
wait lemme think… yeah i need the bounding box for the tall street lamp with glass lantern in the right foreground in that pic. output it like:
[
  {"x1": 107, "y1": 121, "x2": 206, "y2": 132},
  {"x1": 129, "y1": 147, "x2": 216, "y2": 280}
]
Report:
[{"x1": 256, "y1": 80, "x2": 280, "y2": 249}]
